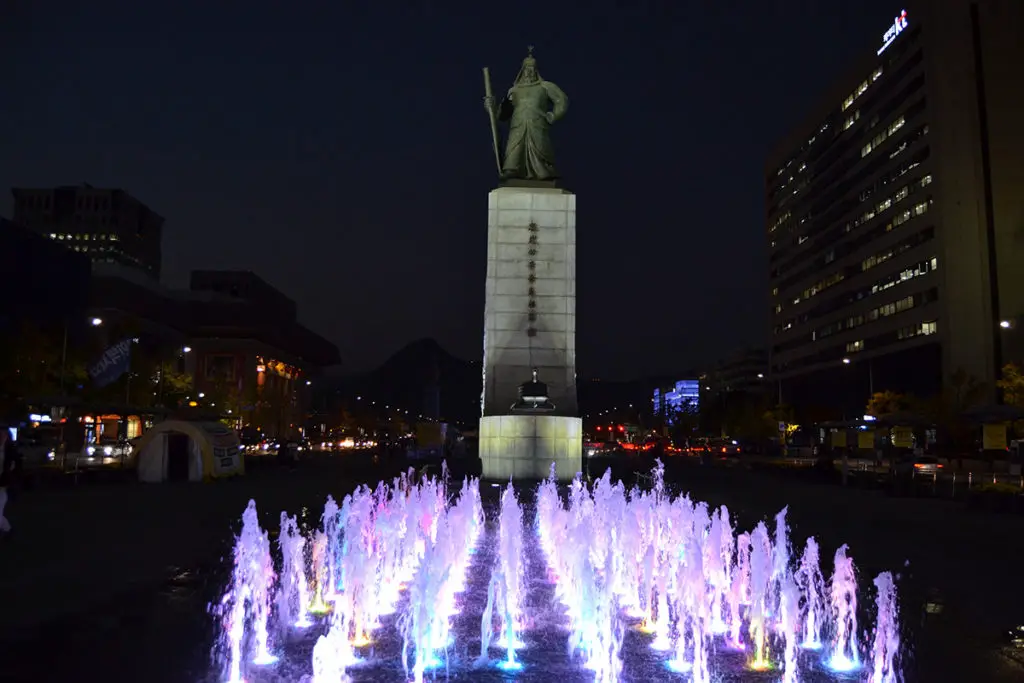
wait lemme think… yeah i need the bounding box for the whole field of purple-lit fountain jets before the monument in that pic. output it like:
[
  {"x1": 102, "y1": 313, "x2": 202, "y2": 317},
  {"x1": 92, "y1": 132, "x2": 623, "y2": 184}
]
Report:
[{"x1": 203, "y1": 458, "x2": 901, "y2": 683}]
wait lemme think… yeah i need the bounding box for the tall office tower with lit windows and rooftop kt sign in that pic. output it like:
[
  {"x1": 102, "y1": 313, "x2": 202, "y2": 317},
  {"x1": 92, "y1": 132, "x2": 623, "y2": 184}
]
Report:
[{"x1": 766, "y1": 0, "x2": 1024, "y2": 412}]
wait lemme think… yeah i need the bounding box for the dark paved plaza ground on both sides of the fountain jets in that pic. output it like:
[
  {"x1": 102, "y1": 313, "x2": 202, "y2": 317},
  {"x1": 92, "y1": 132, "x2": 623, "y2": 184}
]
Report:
[{"x1": 0, "y1": 460, "x2": 1024, "y2": 683}]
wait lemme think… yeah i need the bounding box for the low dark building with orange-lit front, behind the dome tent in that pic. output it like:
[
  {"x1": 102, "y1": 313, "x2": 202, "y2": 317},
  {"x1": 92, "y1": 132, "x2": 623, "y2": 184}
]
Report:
[{"x1": 84, "y1": 264, "x2": 340, "y2": 436}]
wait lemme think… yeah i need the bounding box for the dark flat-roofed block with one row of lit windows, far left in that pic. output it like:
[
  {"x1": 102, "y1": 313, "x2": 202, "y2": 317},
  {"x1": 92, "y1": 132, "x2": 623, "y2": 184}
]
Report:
[{"x1": 11, "y1": 184, "x2": 164, "y2": 280}]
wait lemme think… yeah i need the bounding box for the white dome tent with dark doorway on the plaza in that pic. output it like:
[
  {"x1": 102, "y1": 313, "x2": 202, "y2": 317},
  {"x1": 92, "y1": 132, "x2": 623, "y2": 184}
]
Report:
[{"x1": 135, "y1": 420, "x2": 245, "y2": 482}]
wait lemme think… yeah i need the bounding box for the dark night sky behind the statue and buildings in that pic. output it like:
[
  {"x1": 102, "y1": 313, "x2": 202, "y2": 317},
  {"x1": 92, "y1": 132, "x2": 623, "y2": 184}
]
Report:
[{"x1": 0, "y1": 0, "x2": 900, "y2": 377}]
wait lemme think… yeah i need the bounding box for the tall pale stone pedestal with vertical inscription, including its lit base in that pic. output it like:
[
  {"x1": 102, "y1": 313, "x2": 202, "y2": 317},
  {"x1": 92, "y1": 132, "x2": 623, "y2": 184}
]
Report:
[{"x1": 479, "y1": 183, "x2": 583, "y2": 480}]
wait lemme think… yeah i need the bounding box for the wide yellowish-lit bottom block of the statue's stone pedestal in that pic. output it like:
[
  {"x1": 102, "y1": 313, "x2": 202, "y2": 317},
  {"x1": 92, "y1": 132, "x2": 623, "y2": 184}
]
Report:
[{"x1": 480, "y1": 415, "x2": 583, "y2": 481}]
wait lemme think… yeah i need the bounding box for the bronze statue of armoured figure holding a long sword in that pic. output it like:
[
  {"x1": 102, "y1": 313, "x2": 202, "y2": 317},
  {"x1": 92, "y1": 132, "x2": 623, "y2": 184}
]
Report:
[{"x1": 483, "y1": 46, "x2": 569, "y2": 182}]
